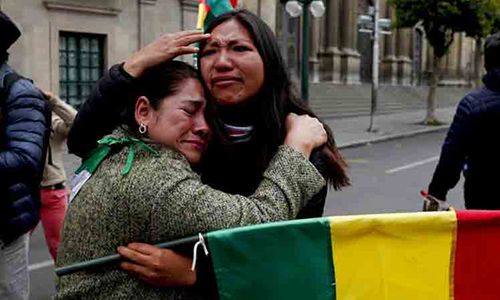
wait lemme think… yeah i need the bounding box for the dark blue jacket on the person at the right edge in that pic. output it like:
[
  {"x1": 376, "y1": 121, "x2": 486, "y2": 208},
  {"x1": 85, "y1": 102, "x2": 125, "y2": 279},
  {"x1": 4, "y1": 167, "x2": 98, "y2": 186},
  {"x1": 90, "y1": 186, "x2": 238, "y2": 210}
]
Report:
[{"x1": 429, "y1": 70, "x2": 500, "y2": 209}]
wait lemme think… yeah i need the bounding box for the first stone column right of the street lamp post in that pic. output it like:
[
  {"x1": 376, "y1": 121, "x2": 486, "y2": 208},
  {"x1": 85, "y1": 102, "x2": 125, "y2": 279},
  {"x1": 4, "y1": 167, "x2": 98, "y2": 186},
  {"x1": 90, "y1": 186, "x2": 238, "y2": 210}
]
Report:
[{"x1": 319, "y1": 0, "x2": 342, "y2": 84}]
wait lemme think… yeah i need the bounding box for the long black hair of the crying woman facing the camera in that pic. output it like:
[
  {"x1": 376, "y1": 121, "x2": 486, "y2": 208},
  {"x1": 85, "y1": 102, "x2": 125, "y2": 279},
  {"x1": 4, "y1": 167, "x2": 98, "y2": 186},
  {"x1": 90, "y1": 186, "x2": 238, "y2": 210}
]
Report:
[{"x1": 198, "y1": 9, "x2": 350, "y2": 190}]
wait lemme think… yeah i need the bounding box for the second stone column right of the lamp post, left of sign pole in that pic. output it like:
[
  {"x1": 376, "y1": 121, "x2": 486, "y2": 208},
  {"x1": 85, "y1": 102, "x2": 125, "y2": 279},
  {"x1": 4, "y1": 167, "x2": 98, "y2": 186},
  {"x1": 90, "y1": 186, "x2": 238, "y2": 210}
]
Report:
[{"x1": 338, "y1": 0, "x2": 361, "y2": 84}]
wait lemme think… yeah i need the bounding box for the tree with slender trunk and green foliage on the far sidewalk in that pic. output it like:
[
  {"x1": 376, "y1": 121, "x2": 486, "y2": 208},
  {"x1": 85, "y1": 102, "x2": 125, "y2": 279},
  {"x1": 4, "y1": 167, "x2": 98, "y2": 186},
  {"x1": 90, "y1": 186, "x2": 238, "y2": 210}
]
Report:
[{"x1": 388, "y1": 0, "x2": 500, "y2": 124}]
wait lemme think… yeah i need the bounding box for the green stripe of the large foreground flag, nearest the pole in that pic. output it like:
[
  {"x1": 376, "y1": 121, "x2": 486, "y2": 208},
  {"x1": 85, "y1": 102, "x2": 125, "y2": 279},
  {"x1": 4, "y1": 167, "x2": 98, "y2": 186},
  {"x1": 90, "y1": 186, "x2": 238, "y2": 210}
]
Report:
[{"x1": 207, "y1": 218, "x2": 335, "y2": 300}]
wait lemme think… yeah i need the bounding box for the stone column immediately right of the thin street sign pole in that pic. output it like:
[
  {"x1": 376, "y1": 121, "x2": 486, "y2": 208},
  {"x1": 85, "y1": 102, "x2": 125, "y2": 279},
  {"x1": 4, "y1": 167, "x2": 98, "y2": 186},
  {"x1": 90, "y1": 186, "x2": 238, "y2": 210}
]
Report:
[{"x1": 381, "y1": 3, "x2": 397, "y2": 85}]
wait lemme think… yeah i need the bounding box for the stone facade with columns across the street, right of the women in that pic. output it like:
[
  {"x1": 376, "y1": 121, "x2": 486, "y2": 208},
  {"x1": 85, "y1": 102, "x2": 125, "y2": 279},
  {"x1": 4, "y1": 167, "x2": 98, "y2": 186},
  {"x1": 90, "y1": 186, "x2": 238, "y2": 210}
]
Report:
[{"x1": 277, "y1": 0, "x2": 475, "y2": 86}]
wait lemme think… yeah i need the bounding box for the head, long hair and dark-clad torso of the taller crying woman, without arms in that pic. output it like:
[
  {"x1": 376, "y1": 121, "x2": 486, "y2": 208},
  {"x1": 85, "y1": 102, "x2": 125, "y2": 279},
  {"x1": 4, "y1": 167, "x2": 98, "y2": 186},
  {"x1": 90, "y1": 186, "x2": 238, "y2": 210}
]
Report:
[{"x1": 198, "y1": 10, "x2": 349, "y2": 218}]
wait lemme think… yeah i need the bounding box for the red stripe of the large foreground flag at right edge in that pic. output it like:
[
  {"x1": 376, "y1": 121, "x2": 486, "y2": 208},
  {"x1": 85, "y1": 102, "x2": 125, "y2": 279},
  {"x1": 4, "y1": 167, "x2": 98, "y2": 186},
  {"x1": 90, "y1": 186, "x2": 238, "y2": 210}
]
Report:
[{"x1": 454, "y1": 210, "x2": 500, "y2": 300}]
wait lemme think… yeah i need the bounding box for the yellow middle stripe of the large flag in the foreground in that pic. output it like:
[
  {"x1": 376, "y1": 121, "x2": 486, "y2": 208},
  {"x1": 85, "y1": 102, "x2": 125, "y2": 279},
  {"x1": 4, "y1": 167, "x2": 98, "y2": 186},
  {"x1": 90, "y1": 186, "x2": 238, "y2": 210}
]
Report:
[{"x1": 330, "y1": 211, "x2": 457, "y2": 300}]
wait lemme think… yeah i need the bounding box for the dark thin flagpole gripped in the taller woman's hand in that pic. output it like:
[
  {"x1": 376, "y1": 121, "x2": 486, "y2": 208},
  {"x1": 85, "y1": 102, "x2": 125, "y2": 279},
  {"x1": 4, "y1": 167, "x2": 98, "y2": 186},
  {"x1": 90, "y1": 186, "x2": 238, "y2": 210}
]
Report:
[{"x1": 55, "y1": 235, "x2": 201, "y2": 277}]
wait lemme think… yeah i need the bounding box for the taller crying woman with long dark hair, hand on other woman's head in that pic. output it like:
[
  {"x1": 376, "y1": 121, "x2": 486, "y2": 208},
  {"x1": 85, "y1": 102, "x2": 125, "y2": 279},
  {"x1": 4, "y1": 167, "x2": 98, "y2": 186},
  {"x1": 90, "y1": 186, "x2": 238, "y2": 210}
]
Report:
[{"x1": 68, "y1": 10, "x2": 349, "y2": 292}]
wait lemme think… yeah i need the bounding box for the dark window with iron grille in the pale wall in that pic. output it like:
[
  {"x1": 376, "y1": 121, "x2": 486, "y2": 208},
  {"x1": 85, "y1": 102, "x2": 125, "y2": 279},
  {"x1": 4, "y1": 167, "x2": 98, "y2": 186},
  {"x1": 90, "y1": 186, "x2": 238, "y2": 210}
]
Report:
[{"x1": 59, "y1": 31, "x2": 105, "y2": 109}]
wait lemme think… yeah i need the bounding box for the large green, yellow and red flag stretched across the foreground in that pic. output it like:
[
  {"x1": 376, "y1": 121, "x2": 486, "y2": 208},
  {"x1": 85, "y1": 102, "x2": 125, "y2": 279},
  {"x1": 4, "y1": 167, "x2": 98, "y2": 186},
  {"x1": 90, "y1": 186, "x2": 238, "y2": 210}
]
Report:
[{"x1": 206, "y1": 210, "x2": 500, "y2": 300}]
